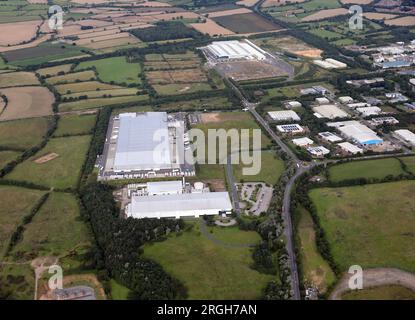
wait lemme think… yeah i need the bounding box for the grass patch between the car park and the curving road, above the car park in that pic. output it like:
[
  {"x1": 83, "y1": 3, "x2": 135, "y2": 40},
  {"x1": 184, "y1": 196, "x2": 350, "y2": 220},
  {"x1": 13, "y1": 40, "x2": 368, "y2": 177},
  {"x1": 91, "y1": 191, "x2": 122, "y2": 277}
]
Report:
[{"x1": 233, "y1": 151, "x2": 285, "y2": 185}]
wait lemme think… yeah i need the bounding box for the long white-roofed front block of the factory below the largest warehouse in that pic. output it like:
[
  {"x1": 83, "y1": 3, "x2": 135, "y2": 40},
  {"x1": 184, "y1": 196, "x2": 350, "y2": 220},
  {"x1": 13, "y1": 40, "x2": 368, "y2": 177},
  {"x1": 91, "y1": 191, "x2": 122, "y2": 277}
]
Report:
[{"x1": 126, "y1": 192, "x2": 232, "y2": 219}]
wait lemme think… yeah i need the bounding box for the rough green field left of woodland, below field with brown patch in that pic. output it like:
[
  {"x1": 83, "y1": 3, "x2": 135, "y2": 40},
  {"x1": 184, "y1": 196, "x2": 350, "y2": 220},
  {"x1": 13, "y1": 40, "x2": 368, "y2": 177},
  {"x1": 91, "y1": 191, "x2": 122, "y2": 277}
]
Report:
[{"x1": 11, "y1": 192, "x2": 91, "y2": 260}]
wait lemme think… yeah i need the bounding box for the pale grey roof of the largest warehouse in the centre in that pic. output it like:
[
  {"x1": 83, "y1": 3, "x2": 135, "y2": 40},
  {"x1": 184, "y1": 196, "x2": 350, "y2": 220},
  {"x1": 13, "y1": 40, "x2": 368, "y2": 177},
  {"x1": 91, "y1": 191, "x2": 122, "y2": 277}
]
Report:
[{"x1": 114, "y1": 112, "x2": 172, "y2": 171}]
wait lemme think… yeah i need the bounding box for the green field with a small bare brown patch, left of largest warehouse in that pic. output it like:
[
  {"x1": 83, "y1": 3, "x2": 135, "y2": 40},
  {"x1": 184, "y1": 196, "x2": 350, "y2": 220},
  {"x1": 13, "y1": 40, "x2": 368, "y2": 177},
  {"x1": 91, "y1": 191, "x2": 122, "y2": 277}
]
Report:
[{"x1": 6, "y1": 136, "x2": 91, "y2": 188}]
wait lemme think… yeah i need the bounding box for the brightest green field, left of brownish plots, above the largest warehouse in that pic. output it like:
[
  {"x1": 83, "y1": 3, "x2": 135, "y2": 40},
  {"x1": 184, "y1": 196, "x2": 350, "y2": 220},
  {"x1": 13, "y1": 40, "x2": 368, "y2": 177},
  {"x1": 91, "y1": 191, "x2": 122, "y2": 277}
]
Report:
[{"x1": 75, "y1": 57, "x2": 141, "y2": 85}]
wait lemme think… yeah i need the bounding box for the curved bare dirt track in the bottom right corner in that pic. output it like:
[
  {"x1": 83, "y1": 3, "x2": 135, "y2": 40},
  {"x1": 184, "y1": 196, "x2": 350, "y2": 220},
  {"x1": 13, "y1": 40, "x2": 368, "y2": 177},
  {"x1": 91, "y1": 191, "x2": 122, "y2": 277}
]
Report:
[{"x1": 329, "y1": 268, "x2": 415, "y2": 300}]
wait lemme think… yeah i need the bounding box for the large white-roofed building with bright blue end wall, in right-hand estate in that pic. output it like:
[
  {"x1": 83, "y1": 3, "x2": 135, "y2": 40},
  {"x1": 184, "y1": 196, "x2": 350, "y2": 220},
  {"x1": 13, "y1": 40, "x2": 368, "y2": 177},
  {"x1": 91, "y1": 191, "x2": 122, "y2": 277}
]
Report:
[{"x1": 327, "y1": 120, "x2": 383, "y2": 145}]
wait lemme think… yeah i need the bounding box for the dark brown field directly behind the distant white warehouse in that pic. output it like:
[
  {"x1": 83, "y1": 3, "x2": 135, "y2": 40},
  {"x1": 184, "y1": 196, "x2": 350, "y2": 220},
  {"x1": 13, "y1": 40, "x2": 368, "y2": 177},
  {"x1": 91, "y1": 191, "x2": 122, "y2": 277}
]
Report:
[{"x1": 213, "y1": 13, "x2": 281, "y2": 34}]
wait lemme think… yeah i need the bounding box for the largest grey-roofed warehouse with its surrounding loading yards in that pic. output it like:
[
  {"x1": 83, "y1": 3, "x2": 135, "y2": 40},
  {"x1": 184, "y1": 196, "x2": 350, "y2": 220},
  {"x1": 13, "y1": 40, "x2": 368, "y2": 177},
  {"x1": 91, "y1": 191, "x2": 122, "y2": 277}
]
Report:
[{"x1": 98, "y1": 112, "x2": 195, "y2": 180}]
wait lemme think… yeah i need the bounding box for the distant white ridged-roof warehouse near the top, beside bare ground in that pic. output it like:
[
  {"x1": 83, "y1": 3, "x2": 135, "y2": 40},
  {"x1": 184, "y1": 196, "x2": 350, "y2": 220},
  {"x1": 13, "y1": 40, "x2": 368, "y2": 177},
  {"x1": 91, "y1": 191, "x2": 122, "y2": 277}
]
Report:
[{"x1": 206, "y1": 40, "x2": 266, "y2": 60}]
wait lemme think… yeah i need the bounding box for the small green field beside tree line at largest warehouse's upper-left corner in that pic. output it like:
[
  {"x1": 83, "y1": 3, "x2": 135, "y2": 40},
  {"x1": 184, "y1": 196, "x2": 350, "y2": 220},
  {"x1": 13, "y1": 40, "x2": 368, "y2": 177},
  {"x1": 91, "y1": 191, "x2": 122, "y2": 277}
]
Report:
[{"x1": 54, "y1": 114, "x2": 96, "y2": 136}]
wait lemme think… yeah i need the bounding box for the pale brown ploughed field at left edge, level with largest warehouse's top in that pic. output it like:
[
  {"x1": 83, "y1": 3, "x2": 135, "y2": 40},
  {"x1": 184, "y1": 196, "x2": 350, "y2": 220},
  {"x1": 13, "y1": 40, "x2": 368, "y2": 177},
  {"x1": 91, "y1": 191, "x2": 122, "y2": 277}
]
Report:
[{"x1": 0, "y1": 86, "x2": 55, "y2": 121}]
